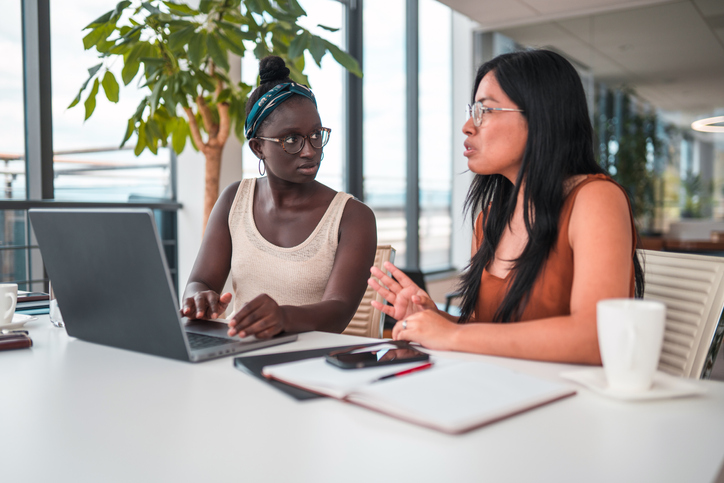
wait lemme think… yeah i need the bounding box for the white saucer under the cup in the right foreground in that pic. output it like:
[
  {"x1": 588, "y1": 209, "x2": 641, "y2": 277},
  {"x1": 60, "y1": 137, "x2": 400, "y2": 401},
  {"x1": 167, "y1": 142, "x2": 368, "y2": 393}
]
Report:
[{"x1": 560, "y1": 367, "x2": 706, "y2": 401}]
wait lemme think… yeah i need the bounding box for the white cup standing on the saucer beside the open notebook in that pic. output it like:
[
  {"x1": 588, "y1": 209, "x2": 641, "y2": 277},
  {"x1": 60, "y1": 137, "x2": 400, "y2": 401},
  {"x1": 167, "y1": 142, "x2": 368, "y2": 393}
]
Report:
[{"x1": 596, "y1": 299, "x2": 666, "y2": 392}]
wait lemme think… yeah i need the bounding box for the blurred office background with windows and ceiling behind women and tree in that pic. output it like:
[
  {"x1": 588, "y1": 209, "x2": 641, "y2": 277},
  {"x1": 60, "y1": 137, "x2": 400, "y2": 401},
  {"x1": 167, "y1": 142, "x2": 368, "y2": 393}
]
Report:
[{"x1": 0, "y1": 0, "x2": 724, "y2": 302}]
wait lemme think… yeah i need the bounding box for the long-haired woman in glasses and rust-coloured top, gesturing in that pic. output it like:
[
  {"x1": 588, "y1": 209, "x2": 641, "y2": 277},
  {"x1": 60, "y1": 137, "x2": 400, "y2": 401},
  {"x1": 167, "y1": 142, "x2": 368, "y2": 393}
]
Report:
[{"x1": 368, "y1": 50, "x2": 643, "y2": 364}]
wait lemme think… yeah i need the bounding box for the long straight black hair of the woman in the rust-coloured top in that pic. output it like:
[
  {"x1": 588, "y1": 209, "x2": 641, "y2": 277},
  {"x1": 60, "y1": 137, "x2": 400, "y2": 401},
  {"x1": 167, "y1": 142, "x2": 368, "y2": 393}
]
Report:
[{"x1": 460, "y1": 50, "x2": 643, "y2": 322}]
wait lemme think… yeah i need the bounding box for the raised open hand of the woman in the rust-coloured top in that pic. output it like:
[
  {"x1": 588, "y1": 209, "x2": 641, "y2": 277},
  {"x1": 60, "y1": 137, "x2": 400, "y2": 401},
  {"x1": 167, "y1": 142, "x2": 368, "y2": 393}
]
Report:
[{"x1": 367, "y1": 262, "x2": 437, "y2": 320}]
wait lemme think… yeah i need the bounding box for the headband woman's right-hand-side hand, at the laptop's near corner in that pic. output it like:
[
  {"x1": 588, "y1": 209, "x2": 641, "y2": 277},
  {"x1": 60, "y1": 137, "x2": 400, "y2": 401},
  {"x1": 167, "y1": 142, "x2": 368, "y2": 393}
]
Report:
[{"x1": 228, "y1": 294, "x2": 286, "y2": 339}]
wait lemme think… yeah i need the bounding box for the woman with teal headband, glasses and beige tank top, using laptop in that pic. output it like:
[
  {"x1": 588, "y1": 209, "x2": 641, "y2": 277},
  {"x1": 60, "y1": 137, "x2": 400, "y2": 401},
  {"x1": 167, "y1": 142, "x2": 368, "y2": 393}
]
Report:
[{"x1": 181, "y1": 56, "x2": 377, "y2": 338}]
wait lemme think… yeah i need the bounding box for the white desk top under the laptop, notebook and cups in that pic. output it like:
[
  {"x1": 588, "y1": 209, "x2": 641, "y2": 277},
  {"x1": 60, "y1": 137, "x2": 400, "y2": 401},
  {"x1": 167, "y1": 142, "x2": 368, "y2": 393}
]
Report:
[{"x1": 0, "y1": 317, "x2": 724, "y2": 483}]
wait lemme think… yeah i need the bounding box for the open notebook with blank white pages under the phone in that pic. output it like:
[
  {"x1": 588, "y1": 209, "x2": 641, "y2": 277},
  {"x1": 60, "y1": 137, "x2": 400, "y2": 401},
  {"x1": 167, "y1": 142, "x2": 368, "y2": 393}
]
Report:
[{"x1": 262, "y1": 357, "x2": 576, "y2": 434}]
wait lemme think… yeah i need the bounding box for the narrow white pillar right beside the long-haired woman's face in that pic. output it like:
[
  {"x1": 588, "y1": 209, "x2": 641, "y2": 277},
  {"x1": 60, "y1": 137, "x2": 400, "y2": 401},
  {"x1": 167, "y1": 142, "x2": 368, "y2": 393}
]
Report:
[{"x1": 452, "y1": 12, "x2": 478, "y2": 270}]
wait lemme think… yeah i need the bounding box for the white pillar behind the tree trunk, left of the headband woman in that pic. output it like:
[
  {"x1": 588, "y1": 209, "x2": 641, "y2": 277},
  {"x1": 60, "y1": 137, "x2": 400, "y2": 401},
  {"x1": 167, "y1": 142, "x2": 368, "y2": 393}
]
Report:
[{"x1": 176, "y1": 56, "x2": 243, "y2": 300}]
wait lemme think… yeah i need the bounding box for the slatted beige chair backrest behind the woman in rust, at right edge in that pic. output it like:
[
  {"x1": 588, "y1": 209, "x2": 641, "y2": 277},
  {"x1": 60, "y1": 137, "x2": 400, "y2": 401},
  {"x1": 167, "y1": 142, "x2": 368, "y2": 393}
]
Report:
[{"x1": 639, "y1": 250, "x2": 724, "y2": 379}]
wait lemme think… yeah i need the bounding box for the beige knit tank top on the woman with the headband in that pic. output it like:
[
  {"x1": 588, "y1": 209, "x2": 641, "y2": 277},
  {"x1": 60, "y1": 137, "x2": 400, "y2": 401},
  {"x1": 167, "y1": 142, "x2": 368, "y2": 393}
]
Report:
[{"x1": 229, "y1": 178, "x2": 352, "y2": 312}]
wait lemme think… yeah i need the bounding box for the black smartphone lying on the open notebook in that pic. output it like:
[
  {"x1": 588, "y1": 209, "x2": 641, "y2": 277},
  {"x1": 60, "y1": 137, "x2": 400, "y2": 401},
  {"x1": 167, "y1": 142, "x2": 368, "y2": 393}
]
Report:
[{"x1": 325, "y1": 342, "x2": 430, "y2": 369}]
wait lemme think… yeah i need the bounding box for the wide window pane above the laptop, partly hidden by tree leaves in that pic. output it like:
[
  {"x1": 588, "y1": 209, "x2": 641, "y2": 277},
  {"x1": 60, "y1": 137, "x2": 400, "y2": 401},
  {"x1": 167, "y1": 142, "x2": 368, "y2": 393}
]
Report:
[{"x1": 50, "y1": 0, "x2": 172, "y2": 201}]
